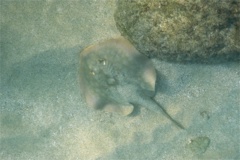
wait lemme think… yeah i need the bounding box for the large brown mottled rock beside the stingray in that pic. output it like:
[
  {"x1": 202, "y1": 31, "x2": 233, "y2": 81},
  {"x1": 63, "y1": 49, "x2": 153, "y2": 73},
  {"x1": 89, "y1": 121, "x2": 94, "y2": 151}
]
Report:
[{"x1": 114, "y1": 0, "x2": 240, "y2": 63}]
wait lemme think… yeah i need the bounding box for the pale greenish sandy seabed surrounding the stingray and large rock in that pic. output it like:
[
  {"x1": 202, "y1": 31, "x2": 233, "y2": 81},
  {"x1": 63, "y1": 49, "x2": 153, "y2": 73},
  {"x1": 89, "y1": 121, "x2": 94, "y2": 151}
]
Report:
[{"x1": 0, "y1": 0, "x2": 240, "y2": 160}]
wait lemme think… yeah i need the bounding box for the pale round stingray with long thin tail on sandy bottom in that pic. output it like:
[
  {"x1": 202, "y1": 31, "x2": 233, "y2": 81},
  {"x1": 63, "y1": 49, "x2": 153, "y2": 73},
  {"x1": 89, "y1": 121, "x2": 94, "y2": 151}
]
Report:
[{"x1": 79, "y1": 37, "x2": 183, "y2": 129}]
